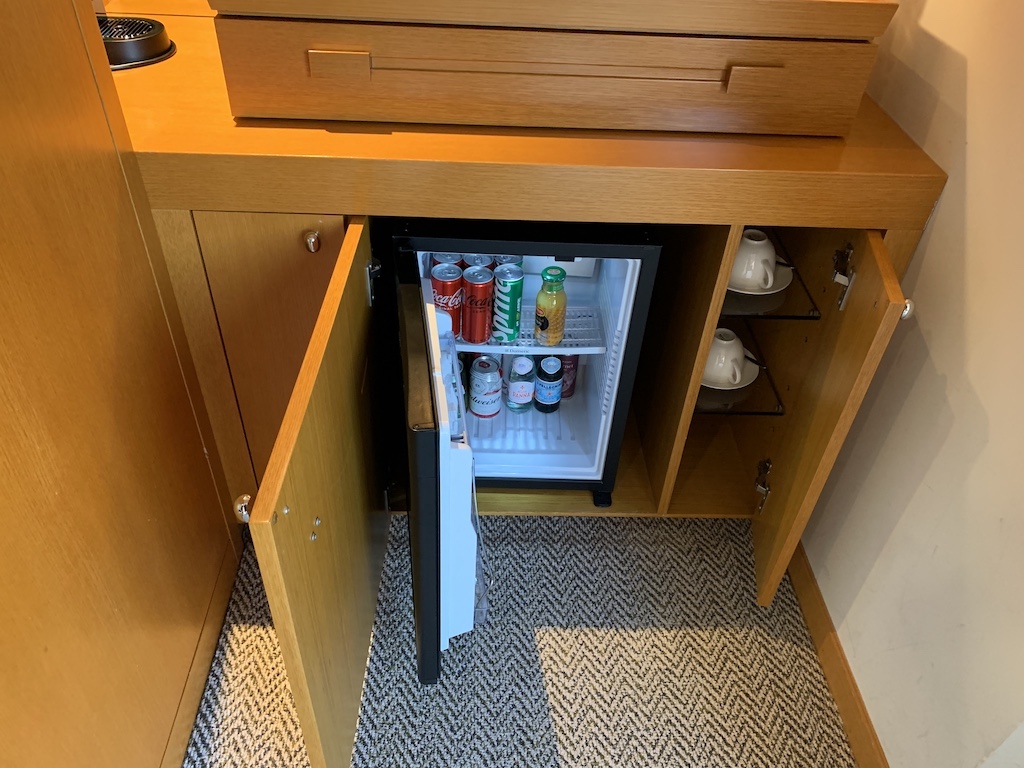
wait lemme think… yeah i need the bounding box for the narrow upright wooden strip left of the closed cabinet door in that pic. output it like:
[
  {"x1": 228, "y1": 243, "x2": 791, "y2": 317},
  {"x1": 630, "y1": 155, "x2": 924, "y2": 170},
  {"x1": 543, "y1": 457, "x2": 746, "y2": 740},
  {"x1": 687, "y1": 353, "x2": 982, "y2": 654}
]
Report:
[{"x1": 153, "y1": 211, "x2": 256, "y2": 505}]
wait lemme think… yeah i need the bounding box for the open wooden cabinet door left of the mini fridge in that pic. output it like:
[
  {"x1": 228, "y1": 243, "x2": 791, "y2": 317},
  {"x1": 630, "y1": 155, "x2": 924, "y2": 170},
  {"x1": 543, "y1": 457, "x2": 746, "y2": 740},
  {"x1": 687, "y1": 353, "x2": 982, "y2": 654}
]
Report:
[{"x1": 250, "y1": 219, "x2": 386, "y2": 766}]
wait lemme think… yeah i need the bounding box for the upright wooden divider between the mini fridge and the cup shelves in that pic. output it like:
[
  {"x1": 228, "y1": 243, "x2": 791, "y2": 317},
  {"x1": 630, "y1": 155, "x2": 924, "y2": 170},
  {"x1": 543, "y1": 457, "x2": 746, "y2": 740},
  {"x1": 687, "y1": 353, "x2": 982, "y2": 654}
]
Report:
[{"x1": 633, "y1": 226, "x2": 742, "y2": 514}]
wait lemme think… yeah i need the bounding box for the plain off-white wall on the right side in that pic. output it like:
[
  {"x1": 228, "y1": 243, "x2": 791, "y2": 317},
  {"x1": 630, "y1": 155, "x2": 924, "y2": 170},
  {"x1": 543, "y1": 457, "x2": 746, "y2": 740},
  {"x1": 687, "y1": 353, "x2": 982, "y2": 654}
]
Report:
[{"x1": 804, "y1": 0, "x2": 1024, "y2": 768}]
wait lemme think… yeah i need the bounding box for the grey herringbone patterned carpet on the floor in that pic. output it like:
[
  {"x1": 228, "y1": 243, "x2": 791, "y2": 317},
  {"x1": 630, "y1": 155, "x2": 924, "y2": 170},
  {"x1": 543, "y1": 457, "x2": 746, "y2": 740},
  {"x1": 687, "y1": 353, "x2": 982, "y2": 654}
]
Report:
[{"x1": 185, "y1": 517, "x2": 854, "y2": 768}]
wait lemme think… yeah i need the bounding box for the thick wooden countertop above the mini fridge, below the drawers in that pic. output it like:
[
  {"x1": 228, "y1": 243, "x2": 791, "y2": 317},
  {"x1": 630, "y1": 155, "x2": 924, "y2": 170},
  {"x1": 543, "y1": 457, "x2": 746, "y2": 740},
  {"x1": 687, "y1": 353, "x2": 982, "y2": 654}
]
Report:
[{"x1": 109, "y1": 5, "x2": 945, "y2": 229}]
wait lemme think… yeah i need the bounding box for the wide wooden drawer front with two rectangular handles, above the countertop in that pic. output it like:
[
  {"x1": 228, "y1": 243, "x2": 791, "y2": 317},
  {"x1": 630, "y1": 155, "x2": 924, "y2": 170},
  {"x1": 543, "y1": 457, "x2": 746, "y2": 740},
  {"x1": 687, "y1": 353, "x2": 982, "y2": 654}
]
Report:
[{"x1": 216, "y1": 16, "x2": 876, "y2": 135}]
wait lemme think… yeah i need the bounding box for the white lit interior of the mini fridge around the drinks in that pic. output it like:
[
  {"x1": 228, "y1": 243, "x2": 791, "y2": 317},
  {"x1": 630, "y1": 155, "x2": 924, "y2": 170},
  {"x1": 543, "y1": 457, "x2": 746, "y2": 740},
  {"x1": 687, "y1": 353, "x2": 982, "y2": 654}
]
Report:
[{"x1": 416, "y1": 251, "x2": 641, "y2": 480}]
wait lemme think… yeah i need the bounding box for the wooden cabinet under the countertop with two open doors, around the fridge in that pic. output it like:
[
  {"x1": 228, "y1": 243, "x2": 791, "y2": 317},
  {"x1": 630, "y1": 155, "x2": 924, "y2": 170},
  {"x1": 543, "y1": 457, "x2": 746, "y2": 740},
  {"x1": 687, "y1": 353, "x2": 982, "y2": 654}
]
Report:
[{"x1": 159, "y1": 212, "x2": 904, "y2": 765}]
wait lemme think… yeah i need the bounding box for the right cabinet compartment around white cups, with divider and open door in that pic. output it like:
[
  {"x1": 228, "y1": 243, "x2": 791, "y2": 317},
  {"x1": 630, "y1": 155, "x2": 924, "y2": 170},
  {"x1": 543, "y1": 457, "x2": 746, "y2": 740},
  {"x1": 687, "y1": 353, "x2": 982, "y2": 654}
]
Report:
[{"x1": 635, "y1": 225, "x2": 905, "y2": 604}]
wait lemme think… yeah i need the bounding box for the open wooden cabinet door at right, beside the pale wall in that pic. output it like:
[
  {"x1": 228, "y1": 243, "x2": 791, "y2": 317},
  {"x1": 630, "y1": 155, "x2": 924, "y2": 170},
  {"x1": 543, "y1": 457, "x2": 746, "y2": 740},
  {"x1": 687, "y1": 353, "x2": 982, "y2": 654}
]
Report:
[{"x1": 754, "y1": 231, "x2": 904, "y2": 605}]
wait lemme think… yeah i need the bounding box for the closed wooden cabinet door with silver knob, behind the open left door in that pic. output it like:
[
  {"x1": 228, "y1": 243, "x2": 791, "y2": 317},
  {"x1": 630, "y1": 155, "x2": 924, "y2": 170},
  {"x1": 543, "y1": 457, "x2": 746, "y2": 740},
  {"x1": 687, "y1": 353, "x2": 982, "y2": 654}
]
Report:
[{"x1": 195, "y1": 211, "x2": 345, "y2": 482}]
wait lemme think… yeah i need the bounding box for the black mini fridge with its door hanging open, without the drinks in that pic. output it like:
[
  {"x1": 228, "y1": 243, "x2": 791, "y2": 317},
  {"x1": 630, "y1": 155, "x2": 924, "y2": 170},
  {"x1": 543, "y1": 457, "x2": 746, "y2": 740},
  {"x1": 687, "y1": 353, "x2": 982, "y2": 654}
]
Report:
[{"x1": 374, "y1": 219, "x2": 662, "y2": 683}]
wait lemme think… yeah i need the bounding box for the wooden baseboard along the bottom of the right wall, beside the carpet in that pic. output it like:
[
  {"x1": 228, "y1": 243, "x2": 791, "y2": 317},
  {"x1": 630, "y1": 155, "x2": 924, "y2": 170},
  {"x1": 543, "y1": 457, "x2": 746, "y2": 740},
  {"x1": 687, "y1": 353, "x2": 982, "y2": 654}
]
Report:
[{"x1": 790, "y1": 545, "x2": 889, "y2": 768}]
